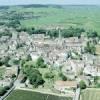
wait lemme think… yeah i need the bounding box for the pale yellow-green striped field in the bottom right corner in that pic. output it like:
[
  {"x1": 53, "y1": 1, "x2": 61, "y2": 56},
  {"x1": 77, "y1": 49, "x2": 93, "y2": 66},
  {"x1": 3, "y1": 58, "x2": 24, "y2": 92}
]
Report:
[{"x1": 81, "y1": 89, "x2": 100, "y2": 100}]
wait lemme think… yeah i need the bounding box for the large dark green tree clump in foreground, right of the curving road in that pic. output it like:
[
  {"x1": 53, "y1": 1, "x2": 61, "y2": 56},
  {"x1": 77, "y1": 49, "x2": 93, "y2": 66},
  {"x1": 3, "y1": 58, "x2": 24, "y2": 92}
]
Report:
[{"x1": 21, "y1": 57, "x2": 47, "y2": 87}]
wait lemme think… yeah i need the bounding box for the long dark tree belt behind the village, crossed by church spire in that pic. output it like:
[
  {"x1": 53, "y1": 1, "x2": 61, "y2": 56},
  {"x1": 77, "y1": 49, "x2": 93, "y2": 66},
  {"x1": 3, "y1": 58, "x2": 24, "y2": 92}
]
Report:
[{"x1": 16, "y1": 27, "x2": 85, "y2": 38}]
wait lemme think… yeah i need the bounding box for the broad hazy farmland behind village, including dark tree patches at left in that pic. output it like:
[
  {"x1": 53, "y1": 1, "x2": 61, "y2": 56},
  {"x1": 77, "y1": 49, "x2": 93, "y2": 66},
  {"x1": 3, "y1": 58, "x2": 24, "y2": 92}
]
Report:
[{"x1": 0, "y1": 5, "x2": 100, "y2": 34}]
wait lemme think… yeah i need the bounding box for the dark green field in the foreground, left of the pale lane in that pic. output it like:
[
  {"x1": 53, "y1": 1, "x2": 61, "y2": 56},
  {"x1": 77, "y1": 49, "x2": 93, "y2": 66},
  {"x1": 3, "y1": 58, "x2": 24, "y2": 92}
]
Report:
[{"x1": 7, "y1": 90, "x2": 72, "y2": 100}]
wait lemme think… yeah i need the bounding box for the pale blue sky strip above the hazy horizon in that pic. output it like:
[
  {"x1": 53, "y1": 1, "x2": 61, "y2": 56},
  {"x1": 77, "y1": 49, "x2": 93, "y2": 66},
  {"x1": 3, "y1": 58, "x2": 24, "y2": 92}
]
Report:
[{"x1": 0, "y1": 0, "x2": 100, "y2": 5}]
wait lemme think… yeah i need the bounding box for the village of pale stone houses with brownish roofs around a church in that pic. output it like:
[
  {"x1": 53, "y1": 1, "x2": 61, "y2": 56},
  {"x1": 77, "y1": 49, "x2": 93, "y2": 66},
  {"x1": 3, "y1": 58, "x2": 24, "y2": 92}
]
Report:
[{"x1": 0, "y1": 27, "x2": 100, "y2": 100}]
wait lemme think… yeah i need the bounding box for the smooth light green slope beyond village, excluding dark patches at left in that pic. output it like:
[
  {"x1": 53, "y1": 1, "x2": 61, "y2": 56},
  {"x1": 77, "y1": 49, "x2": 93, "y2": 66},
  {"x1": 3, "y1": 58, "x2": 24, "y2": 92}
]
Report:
[{"x1": 17, "y1": 6, "x2": 100, "y2": 32}]
